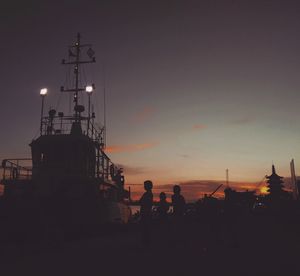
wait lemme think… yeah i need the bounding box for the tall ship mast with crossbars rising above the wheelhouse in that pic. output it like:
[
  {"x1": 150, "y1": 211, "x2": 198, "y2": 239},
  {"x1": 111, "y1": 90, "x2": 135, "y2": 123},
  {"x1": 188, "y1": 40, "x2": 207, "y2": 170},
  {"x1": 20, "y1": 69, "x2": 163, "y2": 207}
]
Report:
[{"x1": 60, "y1": 33, "x2": 96, "y2": 122}]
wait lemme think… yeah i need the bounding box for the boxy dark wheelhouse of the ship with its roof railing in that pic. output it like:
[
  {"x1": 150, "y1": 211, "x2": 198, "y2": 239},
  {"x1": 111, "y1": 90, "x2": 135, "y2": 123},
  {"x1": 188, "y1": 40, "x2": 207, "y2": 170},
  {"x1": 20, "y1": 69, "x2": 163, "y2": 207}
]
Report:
[{"x1": 30, "y1": 110, "x2": 102, "y2": 180}]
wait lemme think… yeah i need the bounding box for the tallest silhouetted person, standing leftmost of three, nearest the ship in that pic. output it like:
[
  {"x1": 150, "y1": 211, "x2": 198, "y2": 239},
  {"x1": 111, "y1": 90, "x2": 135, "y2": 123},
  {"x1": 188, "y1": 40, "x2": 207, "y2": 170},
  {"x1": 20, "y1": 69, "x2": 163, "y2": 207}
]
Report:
[{"x1": 139, "y1": 180, "x2": 153, "y2": 245}]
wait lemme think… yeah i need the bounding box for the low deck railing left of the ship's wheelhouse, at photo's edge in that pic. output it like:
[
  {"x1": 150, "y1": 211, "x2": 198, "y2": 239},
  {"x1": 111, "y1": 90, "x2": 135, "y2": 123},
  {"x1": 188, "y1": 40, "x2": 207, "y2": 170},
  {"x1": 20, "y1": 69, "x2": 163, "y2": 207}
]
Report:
[{"x1": 2, "y1": 158, "x2": 32, "y2": 180}]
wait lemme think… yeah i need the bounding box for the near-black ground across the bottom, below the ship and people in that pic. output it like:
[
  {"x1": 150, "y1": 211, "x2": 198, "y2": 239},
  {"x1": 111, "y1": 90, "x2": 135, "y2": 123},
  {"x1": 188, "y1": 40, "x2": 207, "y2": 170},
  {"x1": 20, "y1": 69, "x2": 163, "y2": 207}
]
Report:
[{"x1": 0, "y1": 214, "x2": 300, "y2": 276}]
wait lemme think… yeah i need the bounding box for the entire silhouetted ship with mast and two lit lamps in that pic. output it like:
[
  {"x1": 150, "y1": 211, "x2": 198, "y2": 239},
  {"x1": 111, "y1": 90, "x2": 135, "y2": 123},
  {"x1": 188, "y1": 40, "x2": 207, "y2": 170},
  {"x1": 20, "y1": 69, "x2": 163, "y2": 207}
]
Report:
[{"x1": 0, "y1": 34, "x2": 131, "y2": 237}]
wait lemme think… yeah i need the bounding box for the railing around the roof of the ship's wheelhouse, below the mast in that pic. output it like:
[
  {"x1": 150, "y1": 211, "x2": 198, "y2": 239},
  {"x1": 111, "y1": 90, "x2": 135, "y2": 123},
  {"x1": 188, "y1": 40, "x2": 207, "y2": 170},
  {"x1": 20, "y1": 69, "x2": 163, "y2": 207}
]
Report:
[{"x1": 41, "y1": 116, "x2": 104, "y2": 142}]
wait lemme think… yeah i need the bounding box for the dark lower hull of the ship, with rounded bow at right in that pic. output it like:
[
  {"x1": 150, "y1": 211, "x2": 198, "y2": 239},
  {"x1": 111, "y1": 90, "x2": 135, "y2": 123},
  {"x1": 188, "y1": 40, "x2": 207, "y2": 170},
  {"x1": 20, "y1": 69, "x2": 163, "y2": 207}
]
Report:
[{"x1": 0, "y1": 180, "x2": 131, "y2": 243}]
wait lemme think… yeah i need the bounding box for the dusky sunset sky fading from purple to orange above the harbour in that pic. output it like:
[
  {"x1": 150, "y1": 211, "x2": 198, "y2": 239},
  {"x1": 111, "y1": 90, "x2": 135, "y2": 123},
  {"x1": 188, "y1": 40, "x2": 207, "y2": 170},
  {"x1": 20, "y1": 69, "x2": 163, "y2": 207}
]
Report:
[{"x1": 0, "y1": 0, "x2": 300, "y2": 202}]
